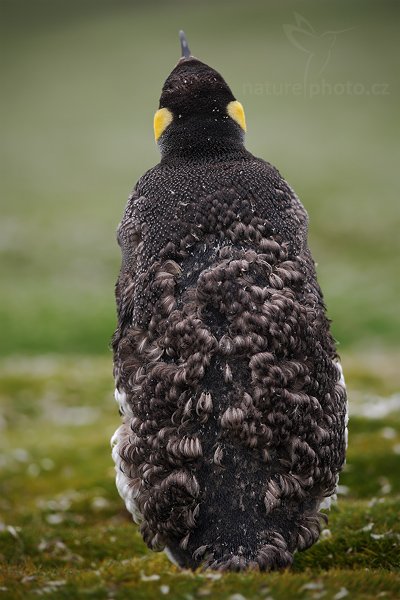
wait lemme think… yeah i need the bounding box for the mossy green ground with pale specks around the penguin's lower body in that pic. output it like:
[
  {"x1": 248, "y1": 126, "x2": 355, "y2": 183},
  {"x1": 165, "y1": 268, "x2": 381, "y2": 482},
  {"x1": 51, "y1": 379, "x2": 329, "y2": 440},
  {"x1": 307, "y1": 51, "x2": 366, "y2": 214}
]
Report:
[{"x1": 0, "y1": 355, "x2": 400, "y2": 600}]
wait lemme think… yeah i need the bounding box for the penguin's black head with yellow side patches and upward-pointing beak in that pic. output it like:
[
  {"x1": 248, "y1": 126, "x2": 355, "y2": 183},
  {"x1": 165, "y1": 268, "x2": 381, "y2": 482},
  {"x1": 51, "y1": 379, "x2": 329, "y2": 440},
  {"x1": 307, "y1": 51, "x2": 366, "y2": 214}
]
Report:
[{"x1": 154, "y1": 31, "x2": 246, "y2": 155}]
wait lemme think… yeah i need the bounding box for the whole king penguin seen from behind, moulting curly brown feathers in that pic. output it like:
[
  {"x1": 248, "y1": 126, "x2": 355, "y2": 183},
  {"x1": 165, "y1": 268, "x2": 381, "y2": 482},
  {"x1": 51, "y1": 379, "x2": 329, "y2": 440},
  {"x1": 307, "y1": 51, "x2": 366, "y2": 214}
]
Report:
[{"x1": 112, "y1": 32, "x2": 347, "y2": 571}]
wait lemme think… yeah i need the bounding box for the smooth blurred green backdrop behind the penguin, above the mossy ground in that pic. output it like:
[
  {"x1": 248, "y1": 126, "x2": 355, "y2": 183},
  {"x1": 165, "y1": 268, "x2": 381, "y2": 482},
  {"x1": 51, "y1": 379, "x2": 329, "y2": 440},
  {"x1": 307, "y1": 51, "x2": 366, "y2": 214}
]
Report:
[{"x1": 0, "y1": 0, "x2": 400, "y2": 355}]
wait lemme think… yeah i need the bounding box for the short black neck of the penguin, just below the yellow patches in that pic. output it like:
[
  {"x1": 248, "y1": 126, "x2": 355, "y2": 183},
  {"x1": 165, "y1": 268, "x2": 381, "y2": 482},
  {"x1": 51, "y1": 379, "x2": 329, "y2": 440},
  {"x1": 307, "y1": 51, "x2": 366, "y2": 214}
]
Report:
[{"x1": 159, "y1": 120, "x2": 247, "y2": 163}]
